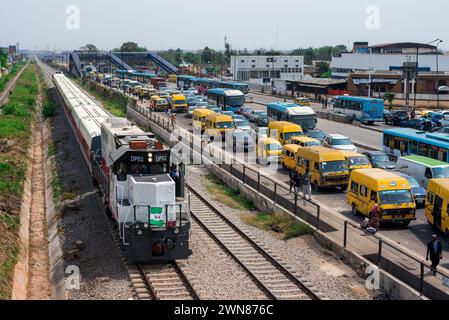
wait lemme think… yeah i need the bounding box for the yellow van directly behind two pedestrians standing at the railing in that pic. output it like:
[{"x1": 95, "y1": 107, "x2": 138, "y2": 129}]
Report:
[{"x1": 295, "y1": 147, "x2": 349, "y2": 191}]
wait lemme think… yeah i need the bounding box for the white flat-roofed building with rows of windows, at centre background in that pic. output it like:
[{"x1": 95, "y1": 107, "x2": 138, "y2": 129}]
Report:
[{"x1": 231, "y1": 56, "x2": 304, "y2": 83}]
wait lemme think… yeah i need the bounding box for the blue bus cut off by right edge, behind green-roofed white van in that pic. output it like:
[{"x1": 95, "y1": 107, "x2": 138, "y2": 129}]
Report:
[{"x1": 382, "y1": 128, "x2": 449, "y2": 162}]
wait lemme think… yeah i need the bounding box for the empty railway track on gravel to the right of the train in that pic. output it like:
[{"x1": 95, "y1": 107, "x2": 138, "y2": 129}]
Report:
[{"x1": 189, "y1": 185, "x2": 323, "y2": 300}]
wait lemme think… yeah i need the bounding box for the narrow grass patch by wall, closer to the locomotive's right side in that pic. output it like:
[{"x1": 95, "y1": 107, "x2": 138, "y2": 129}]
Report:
[{"x1": 206, "y1": 174, "x2": 256, "y2": 211}]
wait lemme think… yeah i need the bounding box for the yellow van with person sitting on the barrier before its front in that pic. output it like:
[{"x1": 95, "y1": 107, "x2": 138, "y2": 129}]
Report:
[{"x1": 347, "y1": 168, "x2": 416, "y2": 226}]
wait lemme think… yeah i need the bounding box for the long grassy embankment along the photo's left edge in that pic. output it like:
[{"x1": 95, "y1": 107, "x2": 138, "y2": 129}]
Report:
[{"x1": 0, "y1": 64, "x2": 38, "y2": 300}]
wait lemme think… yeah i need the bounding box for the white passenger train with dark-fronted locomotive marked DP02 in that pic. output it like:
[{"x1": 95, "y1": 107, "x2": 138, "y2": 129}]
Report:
[{"x1": 53, "y1": 72, "x2": 192, "y2": 263}]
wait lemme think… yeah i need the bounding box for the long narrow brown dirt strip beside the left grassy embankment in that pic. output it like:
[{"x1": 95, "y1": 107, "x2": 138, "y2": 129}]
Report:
[{"x1": 28, "y1": 72, "x2": 51, "y2": 300}]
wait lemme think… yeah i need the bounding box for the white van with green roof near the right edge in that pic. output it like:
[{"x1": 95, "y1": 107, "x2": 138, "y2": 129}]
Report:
[{"x1": 396, "y1": 156, "x2": 449, "y2": 188}]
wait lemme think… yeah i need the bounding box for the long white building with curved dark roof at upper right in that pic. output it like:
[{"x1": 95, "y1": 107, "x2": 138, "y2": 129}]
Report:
[{"x1": 331, "y1": 43, "x2": 449, "y2": 79}]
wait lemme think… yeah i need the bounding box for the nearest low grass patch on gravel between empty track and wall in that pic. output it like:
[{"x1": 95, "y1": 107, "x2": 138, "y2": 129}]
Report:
[{"x1": 243, "y1": 212, "x2": 313, "y2": 240}]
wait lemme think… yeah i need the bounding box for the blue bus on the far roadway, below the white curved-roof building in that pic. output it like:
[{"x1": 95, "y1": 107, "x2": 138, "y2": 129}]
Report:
[{"x1": 334, "y1": 96, "x2": 384, "y2": 124}]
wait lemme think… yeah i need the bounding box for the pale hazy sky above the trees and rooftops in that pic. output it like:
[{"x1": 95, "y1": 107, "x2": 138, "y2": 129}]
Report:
[{"x1": 0, "y1": 0, "x2": 449, "y2": 50}]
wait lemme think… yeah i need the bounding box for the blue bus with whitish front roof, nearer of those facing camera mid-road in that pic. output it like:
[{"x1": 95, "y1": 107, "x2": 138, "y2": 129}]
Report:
[{"x1": 267, "y1": 102, "x2": 318, "y2": 132}]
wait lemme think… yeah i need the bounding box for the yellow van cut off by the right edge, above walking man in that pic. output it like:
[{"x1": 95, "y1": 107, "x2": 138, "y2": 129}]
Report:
[{"x1": 426, "y1": 179, "x2": 449, "y2": 234}]
